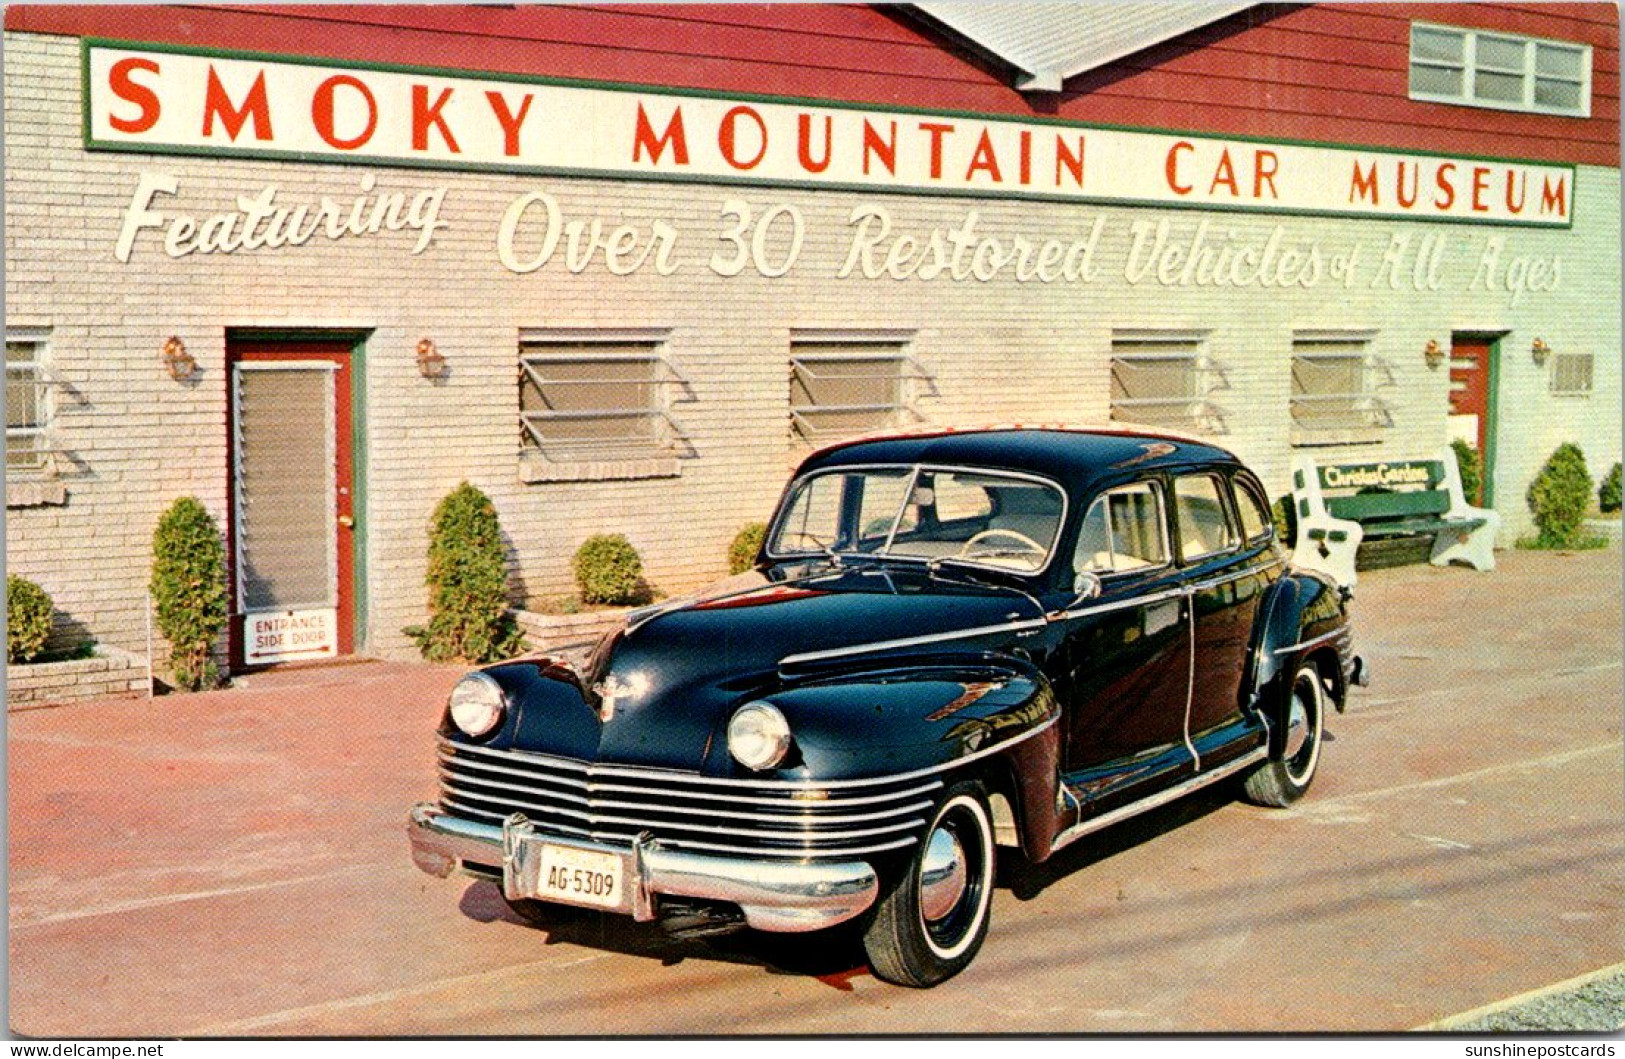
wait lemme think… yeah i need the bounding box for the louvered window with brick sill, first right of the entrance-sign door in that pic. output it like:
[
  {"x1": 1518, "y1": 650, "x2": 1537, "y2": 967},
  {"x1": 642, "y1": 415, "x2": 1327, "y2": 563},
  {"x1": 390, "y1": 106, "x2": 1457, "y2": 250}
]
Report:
[{"x1": 518, "y1": 331, "x2": 686, "y2": 460}]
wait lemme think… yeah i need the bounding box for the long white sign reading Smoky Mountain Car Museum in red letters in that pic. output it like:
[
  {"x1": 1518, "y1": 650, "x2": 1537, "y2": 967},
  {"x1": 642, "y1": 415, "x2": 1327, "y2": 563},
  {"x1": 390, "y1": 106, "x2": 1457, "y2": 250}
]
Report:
[{"x1": 83, "y1": 39, "x2": 1575, "y2": 227}]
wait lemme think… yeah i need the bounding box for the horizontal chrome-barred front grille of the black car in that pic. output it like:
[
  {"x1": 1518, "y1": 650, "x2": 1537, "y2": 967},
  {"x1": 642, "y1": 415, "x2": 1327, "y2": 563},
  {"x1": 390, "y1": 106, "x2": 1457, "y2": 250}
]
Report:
[{"x1": 440, "y1": 739, "x2": 943, "y2": 859}]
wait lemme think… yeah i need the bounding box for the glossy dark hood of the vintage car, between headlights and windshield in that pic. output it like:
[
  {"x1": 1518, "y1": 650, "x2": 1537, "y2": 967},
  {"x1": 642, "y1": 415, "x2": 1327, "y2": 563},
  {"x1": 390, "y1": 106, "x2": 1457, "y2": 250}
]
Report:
[{"x1": 499, "y1": 565, "x2": 1043, "y2": 775}]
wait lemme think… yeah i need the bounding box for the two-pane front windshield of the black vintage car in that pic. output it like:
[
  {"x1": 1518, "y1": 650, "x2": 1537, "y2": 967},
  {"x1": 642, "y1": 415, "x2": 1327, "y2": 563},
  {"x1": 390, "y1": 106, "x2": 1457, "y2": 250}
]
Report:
[{"x1": 769, "y1": 466, "x2": 1066, "y2": 573}]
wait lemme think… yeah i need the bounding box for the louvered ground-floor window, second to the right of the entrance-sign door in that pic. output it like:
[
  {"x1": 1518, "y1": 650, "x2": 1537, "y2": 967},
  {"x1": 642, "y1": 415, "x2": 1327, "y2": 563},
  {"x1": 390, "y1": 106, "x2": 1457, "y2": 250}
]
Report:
[{"x1": 790, "y1": 330, "x2": 930, "y2": 445}]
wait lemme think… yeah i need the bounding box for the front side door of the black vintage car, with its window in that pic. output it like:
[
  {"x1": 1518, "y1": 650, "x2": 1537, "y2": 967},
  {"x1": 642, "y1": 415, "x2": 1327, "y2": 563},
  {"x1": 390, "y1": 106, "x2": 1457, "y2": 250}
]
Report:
[{"x1": 1058, "y1": 479, "x2": 1191, "y2": 817}]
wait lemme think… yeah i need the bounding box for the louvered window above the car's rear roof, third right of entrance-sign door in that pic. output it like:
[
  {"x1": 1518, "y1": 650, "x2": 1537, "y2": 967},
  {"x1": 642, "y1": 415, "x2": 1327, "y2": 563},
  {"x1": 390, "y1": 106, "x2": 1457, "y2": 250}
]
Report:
[{"x1": 1112, "y1": 330, "x2": 1230, "y2": 434}]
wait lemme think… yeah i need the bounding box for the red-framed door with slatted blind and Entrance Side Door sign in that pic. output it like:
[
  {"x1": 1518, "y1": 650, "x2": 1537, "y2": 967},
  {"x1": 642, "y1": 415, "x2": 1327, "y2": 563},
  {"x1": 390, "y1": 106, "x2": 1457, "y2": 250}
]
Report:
[{"x1": 228, "y1": 341, "x2": 356, "y2": 668}]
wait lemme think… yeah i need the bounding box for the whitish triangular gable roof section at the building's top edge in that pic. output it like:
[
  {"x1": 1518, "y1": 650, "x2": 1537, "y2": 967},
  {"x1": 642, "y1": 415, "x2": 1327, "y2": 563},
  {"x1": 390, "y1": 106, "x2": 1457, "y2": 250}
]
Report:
[{"x1": 913, "y1": 0, "x2": 1256, "y2": 93}]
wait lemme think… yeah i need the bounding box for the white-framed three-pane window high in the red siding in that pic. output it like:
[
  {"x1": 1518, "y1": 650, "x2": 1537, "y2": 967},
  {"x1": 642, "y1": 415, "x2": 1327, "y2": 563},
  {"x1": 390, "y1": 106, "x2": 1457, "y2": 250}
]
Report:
[{"x1": 1411, "y1": 23, "x2": 1591, "y2": 117}]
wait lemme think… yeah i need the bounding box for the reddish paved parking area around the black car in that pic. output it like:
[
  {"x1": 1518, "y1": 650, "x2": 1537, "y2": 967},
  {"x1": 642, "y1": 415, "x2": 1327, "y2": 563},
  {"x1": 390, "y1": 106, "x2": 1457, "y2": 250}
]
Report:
[{"x1": 8, "y1": 549, "x2": 1625, "y2": 1036}]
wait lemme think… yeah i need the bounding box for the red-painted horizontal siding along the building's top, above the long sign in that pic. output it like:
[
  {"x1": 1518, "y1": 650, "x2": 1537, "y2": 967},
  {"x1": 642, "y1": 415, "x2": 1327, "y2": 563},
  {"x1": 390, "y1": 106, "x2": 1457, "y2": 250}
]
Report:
[{"x1": 5, "y1": 3, "x2": 1619, "y2": 166}]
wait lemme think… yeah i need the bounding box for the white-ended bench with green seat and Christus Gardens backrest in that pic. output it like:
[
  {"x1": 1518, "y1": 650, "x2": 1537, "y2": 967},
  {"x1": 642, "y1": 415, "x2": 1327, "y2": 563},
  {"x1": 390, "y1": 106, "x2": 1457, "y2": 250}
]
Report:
[{"x1": 1292, "y1": 450, "x2": 1502, "y2": 586}]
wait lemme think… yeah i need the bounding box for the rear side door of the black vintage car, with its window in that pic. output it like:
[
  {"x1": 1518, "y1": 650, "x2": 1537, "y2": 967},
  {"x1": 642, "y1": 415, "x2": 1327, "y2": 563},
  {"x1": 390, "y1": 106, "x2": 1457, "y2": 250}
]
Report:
[{"x1": 1173, "y1": 471, "x2": 1276, "y2": 768}]
